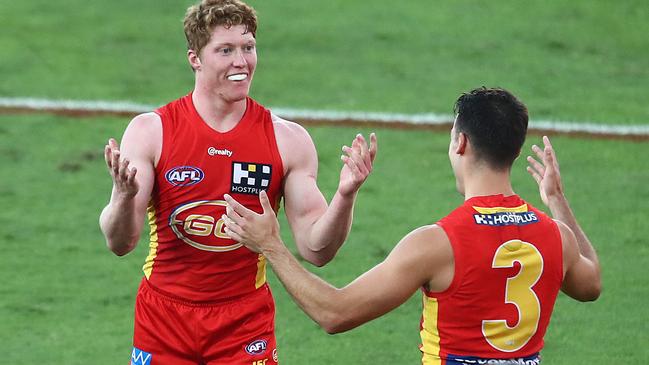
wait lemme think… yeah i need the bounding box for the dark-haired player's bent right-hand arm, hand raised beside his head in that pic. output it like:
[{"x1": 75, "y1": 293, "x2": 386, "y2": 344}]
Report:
[{"x1": 527, "y1": 136, "x2": 601, "y2": 301}]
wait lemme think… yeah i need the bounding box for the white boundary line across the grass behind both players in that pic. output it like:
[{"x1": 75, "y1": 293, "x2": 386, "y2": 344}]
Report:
[{"x1": 0, "y1": 97, "x2": 649, "y2": 136}]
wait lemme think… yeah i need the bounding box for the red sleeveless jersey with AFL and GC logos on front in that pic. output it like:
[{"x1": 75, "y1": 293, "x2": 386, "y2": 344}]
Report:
[{"x1": 143, "y1": 93, "x2": 283, "y2": 301}]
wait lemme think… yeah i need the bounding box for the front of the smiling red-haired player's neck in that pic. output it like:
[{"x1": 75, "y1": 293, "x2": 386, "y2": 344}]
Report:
[{"x1": 192, "y1": 88, "x2": 246, "y2": 132}]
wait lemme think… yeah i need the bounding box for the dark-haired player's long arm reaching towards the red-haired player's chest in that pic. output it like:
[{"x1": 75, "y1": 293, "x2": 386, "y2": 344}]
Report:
[{"x1": 223, "y1": 193, "x2": 446, "y2": 333}]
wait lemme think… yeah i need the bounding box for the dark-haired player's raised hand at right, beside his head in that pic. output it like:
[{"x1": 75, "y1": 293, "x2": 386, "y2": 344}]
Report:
[{"x1": 527, "y1": 136, "x2": 563, "y2": 205}]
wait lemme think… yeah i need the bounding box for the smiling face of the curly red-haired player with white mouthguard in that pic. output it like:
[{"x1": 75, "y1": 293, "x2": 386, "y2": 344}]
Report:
[{"x1": 187, "y1": 25, "x2": 257, "y2": 102}]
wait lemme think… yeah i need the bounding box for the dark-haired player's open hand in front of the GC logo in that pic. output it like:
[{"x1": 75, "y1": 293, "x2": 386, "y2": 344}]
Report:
[{"x1": 221, "y1": 190, "x2": 282, "y2": 253}]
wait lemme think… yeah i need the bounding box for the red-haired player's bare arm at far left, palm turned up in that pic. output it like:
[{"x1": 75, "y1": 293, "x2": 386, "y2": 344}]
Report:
[{"x1": 99, "y1": 113, "x2": 162, "y2": 256}]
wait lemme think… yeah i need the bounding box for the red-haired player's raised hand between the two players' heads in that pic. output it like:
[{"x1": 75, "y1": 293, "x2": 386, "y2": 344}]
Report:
[{"x1": 338, "y1": 133, "x2": 378, "y2": 195}]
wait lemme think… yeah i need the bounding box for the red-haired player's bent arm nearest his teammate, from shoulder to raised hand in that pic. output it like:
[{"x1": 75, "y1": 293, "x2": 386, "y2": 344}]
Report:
[{"x1": 275, "y1": 119, "x2": 376, "y2": 266}]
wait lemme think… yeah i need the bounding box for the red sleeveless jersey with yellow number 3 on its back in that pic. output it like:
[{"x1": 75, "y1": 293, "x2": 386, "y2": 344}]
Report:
[{"x1": 421, "y1": 195, "x2": 563, "y2": 364}]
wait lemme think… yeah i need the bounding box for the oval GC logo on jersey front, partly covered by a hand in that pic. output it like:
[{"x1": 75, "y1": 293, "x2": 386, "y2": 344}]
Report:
[{"x1": 169, "y1": 200, "x2": 243, "y2": 252}]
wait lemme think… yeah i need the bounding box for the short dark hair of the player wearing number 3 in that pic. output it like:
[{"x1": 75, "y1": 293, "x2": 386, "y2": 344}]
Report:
[{"x1": 453, "y1": 86, "x2": 528, "y2": 170}]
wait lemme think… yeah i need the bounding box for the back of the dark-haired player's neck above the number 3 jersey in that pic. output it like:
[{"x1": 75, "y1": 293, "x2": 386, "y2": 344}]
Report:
[{"x1": 464, "y1": 169, "x2": 516, "y2": 200}]
